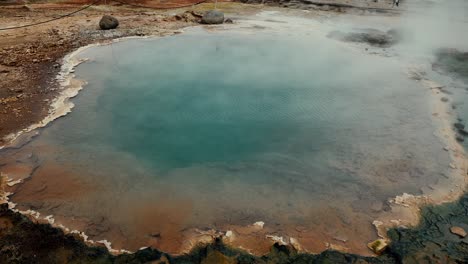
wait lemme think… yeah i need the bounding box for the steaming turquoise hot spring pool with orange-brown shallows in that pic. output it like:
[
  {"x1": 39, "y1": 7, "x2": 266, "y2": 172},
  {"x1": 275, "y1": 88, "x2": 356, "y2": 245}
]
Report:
[{"x1": 0, "y1": 17, "x2": 458, "y2": 254}]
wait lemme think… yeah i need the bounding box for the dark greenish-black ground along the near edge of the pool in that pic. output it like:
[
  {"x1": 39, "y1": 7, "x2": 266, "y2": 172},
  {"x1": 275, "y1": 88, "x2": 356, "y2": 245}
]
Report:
[{"x1": 0, "y1": 194, "x2": 468, "y2": 263}]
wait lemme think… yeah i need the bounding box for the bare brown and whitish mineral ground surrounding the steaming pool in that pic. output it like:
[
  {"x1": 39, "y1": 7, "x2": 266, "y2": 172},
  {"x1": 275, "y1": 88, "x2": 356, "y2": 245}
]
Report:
[{"x1": 0, "y1": 0, "x2": 468, "y2": 263}]
